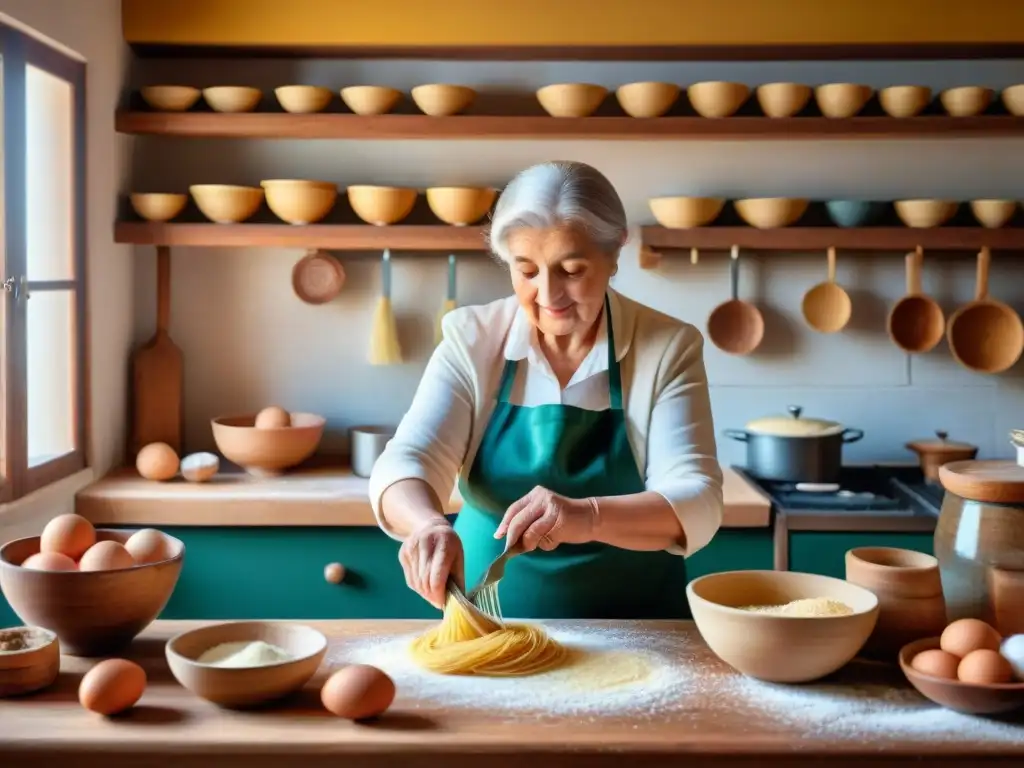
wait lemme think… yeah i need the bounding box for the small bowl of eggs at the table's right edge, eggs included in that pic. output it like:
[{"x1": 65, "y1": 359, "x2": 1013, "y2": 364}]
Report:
[{"x1": 899, "y1": 618, "x2": 1024, "y2": 715}]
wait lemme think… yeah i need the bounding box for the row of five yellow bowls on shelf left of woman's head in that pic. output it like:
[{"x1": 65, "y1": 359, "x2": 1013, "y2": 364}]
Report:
[{"x1": 129, "y1": 179, "x2": 498, "y2": 226}]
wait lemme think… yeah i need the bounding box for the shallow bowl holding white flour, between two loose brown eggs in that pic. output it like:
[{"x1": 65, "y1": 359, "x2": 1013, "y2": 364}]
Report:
[{"x1": 165, "y1": 622, "x2": 327, "y2": 708}]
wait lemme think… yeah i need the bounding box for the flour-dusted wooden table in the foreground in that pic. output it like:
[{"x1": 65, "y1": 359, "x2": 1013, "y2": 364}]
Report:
[{"x1": 0, "y1": 621, "x2": 1024, "y2": 768}]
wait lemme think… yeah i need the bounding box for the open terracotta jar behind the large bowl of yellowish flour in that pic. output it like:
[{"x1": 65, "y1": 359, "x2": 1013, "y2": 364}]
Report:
[{"x1": 846, "y1": 547, "x2": 946, "y2": 664}]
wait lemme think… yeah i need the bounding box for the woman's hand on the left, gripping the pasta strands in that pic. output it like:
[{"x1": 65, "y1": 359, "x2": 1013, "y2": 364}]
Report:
[{"x1": 398, "y1": 518, "x2": 465, "y2": 610}]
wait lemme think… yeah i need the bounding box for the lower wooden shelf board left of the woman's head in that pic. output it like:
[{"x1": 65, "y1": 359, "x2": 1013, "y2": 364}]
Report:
[{"x1": 114, "y1": 221, "x2": 487, "y2": 252}]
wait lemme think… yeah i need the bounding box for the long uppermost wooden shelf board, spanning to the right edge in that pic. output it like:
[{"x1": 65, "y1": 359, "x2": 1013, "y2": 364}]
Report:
[{"x1": 115, "y1": 112, "x2": 1024, "y2": 140}]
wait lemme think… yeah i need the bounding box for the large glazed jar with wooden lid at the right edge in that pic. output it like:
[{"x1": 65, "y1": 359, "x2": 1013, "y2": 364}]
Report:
[{"x1": 935, "y1": 436, "x2": 1024, "y2": 636}]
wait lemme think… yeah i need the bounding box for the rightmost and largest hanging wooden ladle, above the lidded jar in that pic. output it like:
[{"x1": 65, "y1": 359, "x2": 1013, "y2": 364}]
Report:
[{"x1": 946, "y1": 248, "x2": 1024, "y2": 374}]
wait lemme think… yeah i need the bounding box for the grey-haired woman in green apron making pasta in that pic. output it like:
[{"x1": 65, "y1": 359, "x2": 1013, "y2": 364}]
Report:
[{"x1": 370, "y1": 162, "x2": 722, "y2": 618}]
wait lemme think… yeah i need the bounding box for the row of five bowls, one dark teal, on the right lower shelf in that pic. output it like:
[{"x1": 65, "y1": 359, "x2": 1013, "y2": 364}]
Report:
[{"x1": 647, "y1": 197, "x2": 1018, "y2": 229}]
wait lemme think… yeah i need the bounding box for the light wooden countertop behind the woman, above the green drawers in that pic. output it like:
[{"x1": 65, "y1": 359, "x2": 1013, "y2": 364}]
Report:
[{"x1": 75, "y1": 467, "x2": 771, "y2": 528}]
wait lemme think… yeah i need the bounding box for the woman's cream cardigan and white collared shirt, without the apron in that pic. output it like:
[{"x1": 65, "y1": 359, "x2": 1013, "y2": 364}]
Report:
[{"x1": 370, "y1": 290, "x2": 722, "y2": 556}]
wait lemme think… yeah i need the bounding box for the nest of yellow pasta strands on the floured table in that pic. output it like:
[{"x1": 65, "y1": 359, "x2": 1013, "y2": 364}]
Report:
[{"x1": 411, "y1": 595, "x2": 568, "y2": 677}]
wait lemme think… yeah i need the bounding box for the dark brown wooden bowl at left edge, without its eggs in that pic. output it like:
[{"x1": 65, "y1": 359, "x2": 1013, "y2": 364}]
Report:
[{"x1": 0, "y1": 528, "x2": 185, "y2": 656}]
